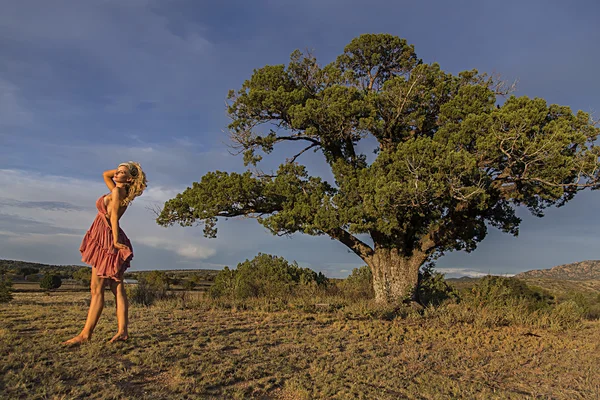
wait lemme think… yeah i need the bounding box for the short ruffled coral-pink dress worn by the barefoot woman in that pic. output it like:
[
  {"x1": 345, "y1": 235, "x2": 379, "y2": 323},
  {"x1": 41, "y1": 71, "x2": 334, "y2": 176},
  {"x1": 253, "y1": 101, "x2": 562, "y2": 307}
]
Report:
[{"x1": 79, "y1": 196, "x2": 133, "y2": 282}]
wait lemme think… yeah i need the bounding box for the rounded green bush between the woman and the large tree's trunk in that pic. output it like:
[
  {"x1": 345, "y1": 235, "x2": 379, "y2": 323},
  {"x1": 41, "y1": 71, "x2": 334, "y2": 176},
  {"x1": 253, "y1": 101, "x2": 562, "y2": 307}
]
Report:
[{"x1": 210, "y1": 253, "x2": 328, "y2": 299}]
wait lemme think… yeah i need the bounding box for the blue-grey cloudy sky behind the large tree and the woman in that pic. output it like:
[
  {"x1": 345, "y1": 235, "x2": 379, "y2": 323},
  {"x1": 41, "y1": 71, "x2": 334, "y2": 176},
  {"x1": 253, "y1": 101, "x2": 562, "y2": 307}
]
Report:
[{"x1": 0, "y1": 0, "x2": 600, "y2": 277}]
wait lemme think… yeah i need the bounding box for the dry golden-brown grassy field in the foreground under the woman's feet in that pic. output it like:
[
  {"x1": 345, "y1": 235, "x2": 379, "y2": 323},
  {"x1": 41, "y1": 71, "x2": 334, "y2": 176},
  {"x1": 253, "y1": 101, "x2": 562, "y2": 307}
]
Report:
[{"x1": 0, "y1": 291, "x2": 600, "y2": 399}]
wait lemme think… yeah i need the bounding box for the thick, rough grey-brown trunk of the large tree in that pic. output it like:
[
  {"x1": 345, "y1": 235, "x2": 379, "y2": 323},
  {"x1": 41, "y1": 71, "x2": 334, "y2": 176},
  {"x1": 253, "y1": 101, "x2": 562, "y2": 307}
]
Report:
[{"x1": 365, "y1": 248, "x2": 427, "y2": 303}]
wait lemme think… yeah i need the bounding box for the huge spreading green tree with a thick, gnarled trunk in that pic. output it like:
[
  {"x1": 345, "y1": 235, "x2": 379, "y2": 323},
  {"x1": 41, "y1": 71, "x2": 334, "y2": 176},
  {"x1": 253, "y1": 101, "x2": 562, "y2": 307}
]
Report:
[{"x1": 157, "y1": 34, "x2": 599, "y2": 301}]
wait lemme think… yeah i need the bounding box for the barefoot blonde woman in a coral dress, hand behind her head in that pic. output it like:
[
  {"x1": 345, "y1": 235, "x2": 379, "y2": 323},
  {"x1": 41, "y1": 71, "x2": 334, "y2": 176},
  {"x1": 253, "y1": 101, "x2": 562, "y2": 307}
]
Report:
[{"x1": 64, "y1": 161, "x2": 146, "y2": 344}]
